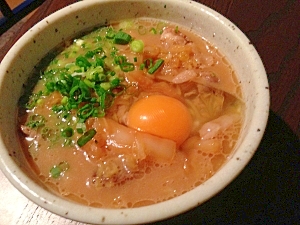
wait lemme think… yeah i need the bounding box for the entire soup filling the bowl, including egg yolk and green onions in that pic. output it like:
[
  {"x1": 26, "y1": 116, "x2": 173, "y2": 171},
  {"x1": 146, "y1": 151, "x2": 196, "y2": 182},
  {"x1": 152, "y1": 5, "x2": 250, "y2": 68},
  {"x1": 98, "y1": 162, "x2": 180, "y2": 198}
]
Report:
[{"x1": 19, "y1": 19, "x2": 243, "y2": 208}]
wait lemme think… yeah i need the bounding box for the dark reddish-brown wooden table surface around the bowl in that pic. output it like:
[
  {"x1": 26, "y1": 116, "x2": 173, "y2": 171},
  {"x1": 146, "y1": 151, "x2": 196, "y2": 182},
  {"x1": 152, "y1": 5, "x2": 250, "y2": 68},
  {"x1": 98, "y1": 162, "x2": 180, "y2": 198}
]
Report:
[{"x1": 0, "y1": 0, "x2": 300, "y2": 225}]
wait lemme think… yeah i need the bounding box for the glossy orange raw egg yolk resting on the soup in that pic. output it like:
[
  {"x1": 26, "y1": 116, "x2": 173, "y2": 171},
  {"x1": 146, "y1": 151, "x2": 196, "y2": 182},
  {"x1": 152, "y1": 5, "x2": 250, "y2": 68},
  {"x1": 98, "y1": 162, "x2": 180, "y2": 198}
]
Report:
[{"x1": 127, "y1": 95, "x2": 192, "y2": 145}]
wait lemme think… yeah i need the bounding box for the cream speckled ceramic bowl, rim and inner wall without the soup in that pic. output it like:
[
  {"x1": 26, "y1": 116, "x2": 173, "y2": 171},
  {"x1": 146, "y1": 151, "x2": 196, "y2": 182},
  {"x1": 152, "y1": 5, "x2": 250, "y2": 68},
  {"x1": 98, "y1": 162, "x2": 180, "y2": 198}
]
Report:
[{"x1": 0, "y1": 0, "x2": 269, "y2": 224}]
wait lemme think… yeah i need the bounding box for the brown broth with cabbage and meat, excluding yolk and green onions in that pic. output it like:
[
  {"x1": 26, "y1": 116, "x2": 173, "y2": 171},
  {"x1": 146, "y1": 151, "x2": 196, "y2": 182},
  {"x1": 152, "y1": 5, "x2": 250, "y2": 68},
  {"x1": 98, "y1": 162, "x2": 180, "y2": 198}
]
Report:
[{"x1": 19, "y1": 20, "x2": 243, "y2": 208}]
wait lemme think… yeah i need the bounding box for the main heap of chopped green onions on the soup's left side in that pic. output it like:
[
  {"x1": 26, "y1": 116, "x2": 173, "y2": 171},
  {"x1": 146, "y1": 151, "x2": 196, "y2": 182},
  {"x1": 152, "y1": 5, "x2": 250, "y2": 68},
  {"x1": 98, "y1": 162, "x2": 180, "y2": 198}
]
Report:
[{"x1": 29, "y1": 27, "x2": 131, "y2": 137}]
